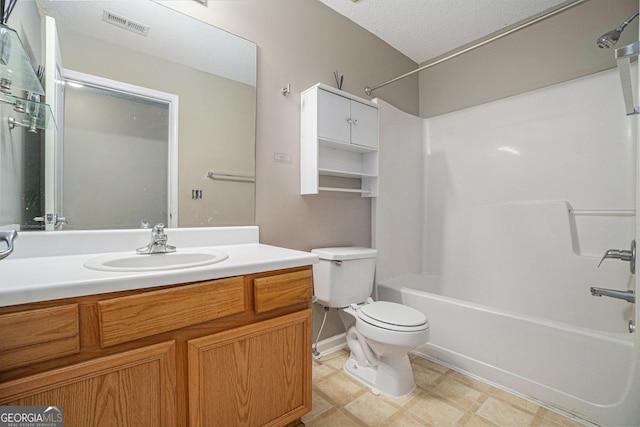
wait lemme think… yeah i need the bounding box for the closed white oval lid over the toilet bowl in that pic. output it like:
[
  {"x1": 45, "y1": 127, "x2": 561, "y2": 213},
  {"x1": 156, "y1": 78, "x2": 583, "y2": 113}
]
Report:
[{"x1": 358, "y1": 301, "x2": 427, "y2": 329}]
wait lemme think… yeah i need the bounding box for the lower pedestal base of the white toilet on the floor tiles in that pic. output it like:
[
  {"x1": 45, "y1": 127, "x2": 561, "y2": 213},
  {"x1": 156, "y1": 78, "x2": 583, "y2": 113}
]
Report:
[{"x1": 344, "y1": 354, "x2": 416, "y2": 397}]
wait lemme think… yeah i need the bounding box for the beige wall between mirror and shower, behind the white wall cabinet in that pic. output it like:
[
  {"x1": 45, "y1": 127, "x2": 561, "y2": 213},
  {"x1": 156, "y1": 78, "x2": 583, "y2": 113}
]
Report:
[{"x1": 162, "y1": 0, "x2": 418, "y2": 254}]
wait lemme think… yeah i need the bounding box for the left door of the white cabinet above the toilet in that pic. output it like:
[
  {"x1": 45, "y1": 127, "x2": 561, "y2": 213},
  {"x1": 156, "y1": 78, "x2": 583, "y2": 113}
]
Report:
[{"x1": 318, "y1": 89, "x2": 351, "y2": 144}]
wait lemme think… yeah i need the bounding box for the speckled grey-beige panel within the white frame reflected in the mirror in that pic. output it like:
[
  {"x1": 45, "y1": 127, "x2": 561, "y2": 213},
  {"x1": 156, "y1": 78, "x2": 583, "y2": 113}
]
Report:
[{"x1": 62, "y1": 79, "x2": 171, "y2": 230}]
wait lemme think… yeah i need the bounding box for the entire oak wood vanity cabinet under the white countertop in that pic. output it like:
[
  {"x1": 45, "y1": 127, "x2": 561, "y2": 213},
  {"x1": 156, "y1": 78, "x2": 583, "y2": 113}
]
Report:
[{"x1": 0, "y1": 267, "x2": 312, "y2": 427}]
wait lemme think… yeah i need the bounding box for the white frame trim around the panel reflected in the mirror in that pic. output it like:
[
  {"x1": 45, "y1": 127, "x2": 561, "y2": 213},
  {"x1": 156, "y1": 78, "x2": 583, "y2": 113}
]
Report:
[{"x1": 64, "y1": 68, "x2": 179, "y2": 228}]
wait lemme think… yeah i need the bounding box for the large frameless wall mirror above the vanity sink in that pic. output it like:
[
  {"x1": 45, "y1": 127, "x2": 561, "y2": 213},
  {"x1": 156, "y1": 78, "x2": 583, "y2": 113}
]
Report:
[{"x1": 0, "y1": 0, "x2": 257, "y2": 230}]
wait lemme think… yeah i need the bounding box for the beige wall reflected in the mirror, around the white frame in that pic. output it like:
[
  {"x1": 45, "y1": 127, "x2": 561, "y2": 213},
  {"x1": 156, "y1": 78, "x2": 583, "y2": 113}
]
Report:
[{"x1": 58, "y1": 29, "x2": 256, "y2": 227}]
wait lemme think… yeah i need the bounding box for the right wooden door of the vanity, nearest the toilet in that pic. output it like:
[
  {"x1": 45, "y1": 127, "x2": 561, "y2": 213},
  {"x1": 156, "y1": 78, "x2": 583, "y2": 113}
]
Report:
[{"x1": 188, "y1": 310, "x2": 311, "y2": 427}]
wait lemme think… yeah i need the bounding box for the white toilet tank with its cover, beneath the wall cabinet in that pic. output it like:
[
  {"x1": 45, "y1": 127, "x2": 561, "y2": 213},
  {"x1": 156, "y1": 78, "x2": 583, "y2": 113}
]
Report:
[{"x1": 311, "y1": 247, "x2": 378, "y2": 307}]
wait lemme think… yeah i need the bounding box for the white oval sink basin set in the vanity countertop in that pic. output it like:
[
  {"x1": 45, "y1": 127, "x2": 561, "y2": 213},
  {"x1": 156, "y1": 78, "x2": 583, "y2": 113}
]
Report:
[{"x1": 84, "y1": 249, "x2": 228, "y2": 271}]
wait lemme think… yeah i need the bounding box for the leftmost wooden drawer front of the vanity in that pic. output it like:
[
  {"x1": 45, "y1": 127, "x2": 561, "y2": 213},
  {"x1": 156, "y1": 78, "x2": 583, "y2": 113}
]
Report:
[{"x1": 0, "y1": 304, "x2": 80, "y2": 370}]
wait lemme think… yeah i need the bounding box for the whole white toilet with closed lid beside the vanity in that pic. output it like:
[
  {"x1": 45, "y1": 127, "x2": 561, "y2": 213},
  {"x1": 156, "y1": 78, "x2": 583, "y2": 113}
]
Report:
[{"x1": 311, "y1": 247, "x2": 429, "y2": 397}]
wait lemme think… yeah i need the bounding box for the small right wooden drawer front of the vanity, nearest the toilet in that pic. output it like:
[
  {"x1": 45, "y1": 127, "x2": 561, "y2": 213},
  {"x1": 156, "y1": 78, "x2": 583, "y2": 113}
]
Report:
[{"x1": 253, "y1": 268, "x2": 313, "y2": 313}]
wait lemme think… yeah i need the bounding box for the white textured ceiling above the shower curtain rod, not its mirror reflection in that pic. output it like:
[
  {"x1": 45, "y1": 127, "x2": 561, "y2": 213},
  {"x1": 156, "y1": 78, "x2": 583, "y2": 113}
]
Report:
[{"x1": 320, "y1": 0, "x2": 565, "y2": 63}]
